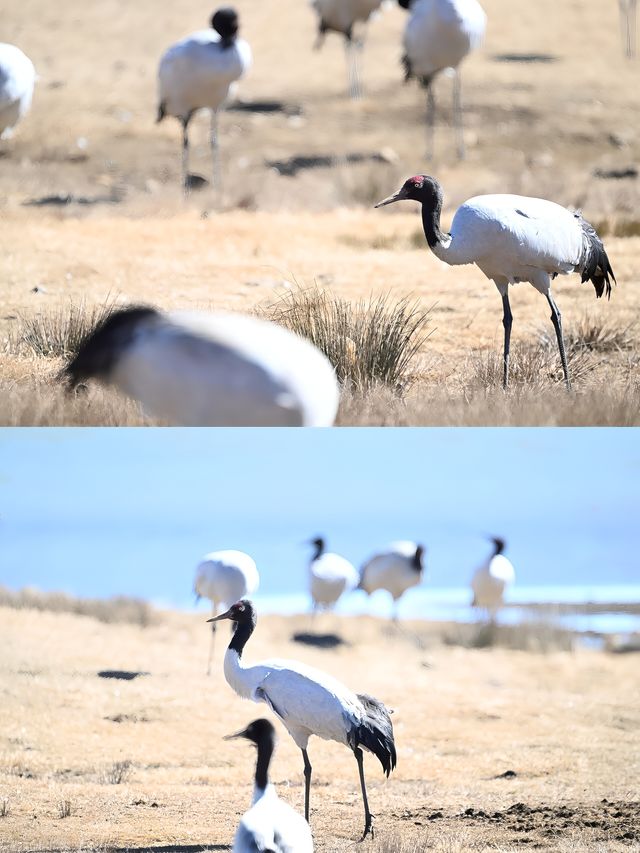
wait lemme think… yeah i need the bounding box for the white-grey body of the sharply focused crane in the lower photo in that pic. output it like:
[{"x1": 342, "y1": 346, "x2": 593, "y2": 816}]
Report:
[{"x1": 224, "y1": 649, "x2": 365, "y2": 749}]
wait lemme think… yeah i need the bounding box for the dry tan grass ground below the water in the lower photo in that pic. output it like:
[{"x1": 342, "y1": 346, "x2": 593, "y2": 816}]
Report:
[{"x1": 0, "y1": 607, "x2": 640, "y2": 853}]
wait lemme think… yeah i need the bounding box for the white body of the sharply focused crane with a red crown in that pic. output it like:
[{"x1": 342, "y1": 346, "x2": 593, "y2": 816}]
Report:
[{"x1": 432, "y1": 194, "x2": 587, "y2": 295}]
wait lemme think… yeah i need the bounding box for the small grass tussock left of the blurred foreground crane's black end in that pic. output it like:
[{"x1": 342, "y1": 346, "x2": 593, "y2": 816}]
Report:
[{"x1": 9, "y1": 300, "x2": 118, "y2": 359}]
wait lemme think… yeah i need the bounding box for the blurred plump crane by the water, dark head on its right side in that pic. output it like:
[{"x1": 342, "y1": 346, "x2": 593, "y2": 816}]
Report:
[{"x1": 358, "y1": 541, "x2": 425, "y2": 622}]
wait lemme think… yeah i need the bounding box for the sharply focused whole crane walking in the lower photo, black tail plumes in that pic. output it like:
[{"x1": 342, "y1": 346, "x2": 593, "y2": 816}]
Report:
[{"x1": 209, "y1": 600, "x2": 396, "y2": 839}]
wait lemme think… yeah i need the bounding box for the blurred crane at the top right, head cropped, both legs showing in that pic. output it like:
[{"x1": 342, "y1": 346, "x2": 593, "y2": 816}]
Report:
[{"x1": 398, "y1": 0, "x2": 487, "y2": 159}]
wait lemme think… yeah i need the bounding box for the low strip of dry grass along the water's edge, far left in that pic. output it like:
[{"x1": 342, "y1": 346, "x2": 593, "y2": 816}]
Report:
[{"x1": 0, "y1": 586, "x2": 158, "y2": 628}]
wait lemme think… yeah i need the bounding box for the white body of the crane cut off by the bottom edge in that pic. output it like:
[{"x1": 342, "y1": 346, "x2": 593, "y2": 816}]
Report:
[{"x1": 233, "y1": 784, "x2": 313, "y2": 853}]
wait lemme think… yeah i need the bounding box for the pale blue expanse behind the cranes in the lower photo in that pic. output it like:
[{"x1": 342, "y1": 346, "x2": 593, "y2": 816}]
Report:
[{"x1": 0, "y1": 429, "x2": 640, "y2": 606}]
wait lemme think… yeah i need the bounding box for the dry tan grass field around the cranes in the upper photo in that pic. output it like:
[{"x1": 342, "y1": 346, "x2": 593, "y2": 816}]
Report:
[{"x1": 0, "y1": 0, "x2": 640, "y2": 424}]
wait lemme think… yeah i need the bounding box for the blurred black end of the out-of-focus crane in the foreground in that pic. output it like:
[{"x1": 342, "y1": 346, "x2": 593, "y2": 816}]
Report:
[{"x1": 59, "y1": 305, "x2": 161, "y2": 388}]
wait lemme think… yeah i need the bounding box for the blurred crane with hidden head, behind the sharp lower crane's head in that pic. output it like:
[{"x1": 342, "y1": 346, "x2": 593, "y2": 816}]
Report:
[{"x1": 193, "y1": 550, "x2": 260, "y2": 675}]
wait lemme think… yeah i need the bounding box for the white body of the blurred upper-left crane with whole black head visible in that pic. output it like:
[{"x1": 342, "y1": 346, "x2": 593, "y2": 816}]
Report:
[{"x1": 158, "y1": 29, "x2": 252, "y2": 121}]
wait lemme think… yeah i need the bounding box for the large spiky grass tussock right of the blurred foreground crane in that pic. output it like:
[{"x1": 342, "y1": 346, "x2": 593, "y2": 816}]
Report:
[{"x1": 265, "y1": 286, "x2": 431, "y2": 392}]
